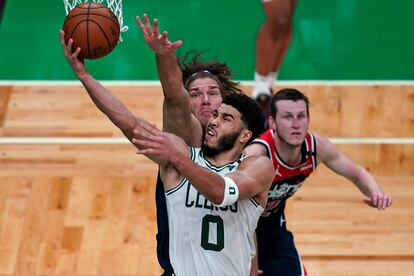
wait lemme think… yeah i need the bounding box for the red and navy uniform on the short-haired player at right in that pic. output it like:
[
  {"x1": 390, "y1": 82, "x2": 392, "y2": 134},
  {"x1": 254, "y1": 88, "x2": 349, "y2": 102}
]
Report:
[{"x1": 252, "y1": 129, "x2": 317, "y2": 276}]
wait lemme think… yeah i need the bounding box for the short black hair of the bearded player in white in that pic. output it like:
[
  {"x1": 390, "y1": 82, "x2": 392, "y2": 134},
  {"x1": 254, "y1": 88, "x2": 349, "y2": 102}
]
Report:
[{"x1": 222, "y1": 93, "x2": 265, "y2": 144}]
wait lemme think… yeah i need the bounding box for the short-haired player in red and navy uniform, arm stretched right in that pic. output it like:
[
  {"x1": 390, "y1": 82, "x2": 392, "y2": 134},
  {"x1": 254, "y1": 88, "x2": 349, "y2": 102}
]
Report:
[{"x1": 246, "y1": 88, "x2": 392, "y2": 276}]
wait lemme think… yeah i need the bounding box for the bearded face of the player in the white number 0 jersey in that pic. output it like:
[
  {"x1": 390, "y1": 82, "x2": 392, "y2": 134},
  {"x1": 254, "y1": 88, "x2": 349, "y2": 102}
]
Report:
[{"x1": 204, "y1": 104, "x2": 244, "y2": 151}]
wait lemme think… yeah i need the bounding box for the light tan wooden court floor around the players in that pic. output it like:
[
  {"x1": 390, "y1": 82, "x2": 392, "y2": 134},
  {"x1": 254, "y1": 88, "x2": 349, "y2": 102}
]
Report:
[{"x1": 0, "y1": 85, "x2": 414, "y2": 275}]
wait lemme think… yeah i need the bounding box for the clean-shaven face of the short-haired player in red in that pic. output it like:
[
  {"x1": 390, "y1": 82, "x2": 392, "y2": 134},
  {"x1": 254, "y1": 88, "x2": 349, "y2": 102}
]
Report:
[{"x1": 271, "y1": 100, "x2": 309, "y2": 146}]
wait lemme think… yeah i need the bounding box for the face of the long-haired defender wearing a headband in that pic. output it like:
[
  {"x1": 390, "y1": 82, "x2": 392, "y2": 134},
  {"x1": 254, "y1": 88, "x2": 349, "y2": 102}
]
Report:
[{"x1": 188, "y1": 78, "x2": 223, "y2": 128}]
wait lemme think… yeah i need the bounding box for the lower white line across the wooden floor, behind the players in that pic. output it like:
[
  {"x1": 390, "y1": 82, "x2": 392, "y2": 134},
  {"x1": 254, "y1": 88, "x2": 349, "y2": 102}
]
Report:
[{"x1": 0, "y1": 137, "x2": 414, "y2": 145}]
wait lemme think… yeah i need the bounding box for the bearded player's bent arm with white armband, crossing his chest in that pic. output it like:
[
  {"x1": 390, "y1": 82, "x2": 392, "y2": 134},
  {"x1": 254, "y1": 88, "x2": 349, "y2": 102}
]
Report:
[{"x1": 133, "y1": 133, "x2": 273, "y2": 206}]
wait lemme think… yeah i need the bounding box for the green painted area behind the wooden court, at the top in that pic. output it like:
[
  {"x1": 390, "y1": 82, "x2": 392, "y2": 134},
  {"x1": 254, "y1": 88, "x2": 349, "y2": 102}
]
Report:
[{"x1": 0, "y1": 0, "x2": 414, "y2": 80}]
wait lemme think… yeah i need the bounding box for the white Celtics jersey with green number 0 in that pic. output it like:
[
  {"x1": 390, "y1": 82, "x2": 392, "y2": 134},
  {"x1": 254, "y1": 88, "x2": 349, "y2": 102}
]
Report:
[{"x1": 166, "y1": 148, "x2": 263, "y2": 276}]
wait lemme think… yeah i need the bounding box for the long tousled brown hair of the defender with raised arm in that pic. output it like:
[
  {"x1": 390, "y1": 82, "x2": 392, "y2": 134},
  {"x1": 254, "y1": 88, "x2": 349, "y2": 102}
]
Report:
[{"x1": 178, "y1": 51, "x2": 242, "y2": 96}]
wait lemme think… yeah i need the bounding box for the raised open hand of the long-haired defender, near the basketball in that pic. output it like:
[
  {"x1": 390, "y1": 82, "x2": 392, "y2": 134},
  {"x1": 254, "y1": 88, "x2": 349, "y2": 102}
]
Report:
[{"x1": 136, "y1": 14, "x2": 183, "y2": 55}]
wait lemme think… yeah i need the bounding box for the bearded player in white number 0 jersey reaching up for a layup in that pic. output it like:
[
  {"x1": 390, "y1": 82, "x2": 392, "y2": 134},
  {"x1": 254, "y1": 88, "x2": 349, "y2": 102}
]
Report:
[{"x1": 60, "y1": 17, "x2": 273, "y2": 276}]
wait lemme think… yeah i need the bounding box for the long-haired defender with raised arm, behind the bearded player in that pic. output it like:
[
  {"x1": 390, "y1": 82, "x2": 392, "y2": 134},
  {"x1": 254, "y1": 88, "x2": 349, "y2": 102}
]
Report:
[{"x1": 137, "y1": 14, "x2": 241, "y2": 275}]
